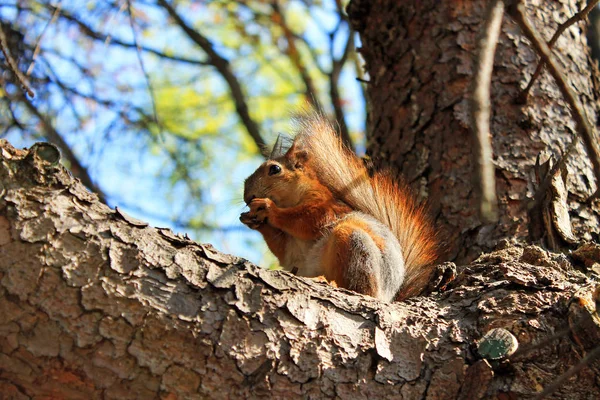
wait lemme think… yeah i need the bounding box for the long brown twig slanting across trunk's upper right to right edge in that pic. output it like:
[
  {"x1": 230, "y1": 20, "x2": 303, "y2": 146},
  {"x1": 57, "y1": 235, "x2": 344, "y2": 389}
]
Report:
[{"x1": 509, "y1": 1, "x2": 600, "y2": 203}]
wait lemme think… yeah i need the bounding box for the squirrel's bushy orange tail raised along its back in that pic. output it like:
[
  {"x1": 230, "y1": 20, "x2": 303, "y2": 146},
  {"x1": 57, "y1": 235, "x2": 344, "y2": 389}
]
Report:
[{"x1": 294, "y1": 112, "x2": 437, "y2": 300}]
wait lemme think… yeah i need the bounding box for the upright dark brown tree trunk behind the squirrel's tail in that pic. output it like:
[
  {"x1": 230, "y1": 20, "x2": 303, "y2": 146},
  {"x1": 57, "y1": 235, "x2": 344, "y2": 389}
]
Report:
[{"x1": 348, "y1": 0, "x2": 600, "y2": 260}]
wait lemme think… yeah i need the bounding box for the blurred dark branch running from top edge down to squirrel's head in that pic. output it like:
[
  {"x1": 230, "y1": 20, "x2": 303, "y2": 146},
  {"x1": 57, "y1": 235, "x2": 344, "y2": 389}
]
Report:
[{"x1": 158, "y1": 0, "x2": 265, "y2": 149}]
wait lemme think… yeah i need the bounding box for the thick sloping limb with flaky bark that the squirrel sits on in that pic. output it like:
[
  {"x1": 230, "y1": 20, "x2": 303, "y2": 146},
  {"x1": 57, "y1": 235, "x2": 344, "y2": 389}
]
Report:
[{"x1": 0, "y1": 142, "x2": 600, "y2": 399}]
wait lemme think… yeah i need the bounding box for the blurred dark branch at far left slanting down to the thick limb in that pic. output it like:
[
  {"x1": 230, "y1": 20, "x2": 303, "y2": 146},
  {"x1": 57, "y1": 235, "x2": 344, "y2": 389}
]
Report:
[{"x1": 19, "y1": 95, "x2": 106, "y2": 204}]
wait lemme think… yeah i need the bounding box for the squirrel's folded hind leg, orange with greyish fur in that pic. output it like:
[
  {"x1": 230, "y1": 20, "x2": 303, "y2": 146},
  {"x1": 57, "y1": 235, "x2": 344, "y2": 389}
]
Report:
[{"x1": 320, "y1": 218, "x2": 385, "y2": 298}]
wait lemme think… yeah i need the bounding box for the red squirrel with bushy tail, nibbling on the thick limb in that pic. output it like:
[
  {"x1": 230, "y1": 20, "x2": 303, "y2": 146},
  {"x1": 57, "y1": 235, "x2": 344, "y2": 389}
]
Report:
[{"x1": 240, "y1": 111, "x2": 438, "y2": 302}]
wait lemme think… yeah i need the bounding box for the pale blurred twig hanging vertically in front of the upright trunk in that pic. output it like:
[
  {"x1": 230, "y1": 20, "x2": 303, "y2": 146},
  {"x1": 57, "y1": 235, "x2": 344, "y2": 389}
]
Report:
[{"x1": 471, "y1": 0, "x2": 504, "y2": 223}]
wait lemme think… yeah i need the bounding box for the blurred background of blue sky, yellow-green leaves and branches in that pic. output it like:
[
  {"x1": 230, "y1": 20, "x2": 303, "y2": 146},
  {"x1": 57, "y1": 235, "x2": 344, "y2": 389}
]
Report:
[{"x1": 0, "y1": 0, "x2": 364, "y2": 263}]
